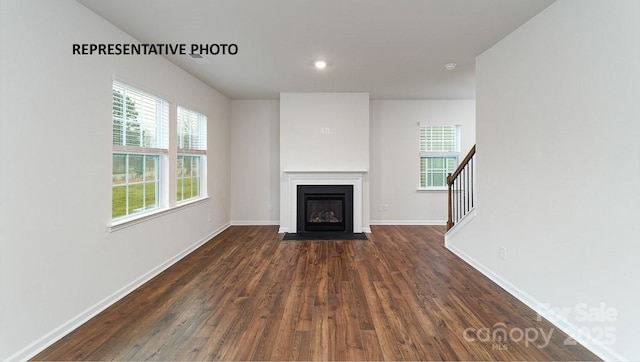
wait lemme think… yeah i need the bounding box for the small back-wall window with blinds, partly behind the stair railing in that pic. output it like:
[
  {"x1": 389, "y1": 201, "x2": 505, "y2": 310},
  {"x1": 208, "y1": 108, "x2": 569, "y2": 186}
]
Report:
[{"x1": 420, "y1": 124, "x2": 460, "y2": 189}]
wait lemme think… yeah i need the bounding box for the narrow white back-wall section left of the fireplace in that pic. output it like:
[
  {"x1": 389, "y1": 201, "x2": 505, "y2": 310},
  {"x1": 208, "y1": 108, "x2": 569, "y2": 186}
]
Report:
[{"x1": 231, "y1": 100, "x2": 280, "y2": 225}]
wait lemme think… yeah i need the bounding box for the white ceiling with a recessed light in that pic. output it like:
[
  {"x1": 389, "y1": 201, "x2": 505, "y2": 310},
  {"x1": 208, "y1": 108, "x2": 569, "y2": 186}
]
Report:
[{"x1": 78, "y1": 0, "x2": 554, "y2": 99}]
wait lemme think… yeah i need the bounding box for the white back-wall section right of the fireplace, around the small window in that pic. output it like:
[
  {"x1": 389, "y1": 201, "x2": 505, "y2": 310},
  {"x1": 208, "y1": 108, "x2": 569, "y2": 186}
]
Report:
[{"x1": 370, "y1": 100, "x2": 475, "y2": 225}]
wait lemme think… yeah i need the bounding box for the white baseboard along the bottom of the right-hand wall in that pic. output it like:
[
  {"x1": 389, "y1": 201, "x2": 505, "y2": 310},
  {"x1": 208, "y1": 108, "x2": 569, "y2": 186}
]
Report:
[{"x1": 445, "y1": 239, "x2": 628, "y2": 361}]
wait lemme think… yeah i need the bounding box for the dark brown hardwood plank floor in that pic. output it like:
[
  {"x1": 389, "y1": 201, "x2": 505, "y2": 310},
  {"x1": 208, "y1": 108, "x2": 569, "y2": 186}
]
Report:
[{"x1": 34, "y1": 226, "x2": 598, "y2": 360}]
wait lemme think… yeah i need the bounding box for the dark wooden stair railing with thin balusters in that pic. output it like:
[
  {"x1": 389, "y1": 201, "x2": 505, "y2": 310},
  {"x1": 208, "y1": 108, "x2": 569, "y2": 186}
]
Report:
[{"x1": 447, "y1": 145, "x2": 476, "y2": 230}]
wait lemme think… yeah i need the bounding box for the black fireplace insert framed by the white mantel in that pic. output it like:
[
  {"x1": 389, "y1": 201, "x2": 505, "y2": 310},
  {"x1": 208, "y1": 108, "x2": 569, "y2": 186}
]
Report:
[{"x1": 296, "y1": 185, "x2": 353, "y2": 233}]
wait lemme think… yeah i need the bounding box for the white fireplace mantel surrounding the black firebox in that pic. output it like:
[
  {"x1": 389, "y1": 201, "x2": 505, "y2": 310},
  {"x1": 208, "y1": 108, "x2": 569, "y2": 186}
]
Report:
[{"x1": 279, "y1": 170, "x2": 367, "y2": 233}]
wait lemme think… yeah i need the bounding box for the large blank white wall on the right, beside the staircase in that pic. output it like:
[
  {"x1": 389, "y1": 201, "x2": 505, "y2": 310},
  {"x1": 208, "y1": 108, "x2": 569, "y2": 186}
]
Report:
[{"x1": 448, "y1": 0, "x2": 640, "y2": 360}]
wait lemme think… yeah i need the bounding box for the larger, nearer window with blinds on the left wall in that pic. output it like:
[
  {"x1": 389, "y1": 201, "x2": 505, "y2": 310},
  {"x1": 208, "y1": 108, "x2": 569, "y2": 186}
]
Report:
[{"x1": 111, "y1": 82, "x2": 169, "y2": 219}]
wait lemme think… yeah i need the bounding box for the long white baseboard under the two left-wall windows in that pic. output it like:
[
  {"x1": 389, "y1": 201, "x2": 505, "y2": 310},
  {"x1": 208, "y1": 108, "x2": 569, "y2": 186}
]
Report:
[{"x1": 7, "y1": 223, "x2": 230, "y2": 361}]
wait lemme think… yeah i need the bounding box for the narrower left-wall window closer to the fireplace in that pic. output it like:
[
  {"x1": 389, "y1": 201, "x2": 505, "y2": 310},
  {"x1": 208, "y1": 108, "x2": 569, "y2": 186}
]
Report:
[{"x1": 177, "y1": 107, "x2": 207, "y2": 202}]
